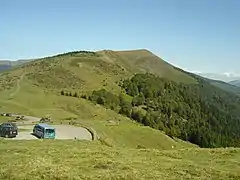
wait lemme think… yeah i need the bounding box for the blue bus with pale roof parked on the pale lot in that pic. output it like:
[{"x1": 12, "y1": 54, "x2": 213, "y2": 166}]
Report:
[{"x1": 33, "y1": 123, "x2": 56, "y2": 139}]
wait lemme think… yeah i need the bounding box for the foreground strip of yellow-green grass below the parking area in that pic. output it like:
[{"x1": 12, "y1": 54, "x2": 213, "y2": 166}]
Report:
[{"x1": 0, "y1": 140, "x2": 240, "y2": 180}]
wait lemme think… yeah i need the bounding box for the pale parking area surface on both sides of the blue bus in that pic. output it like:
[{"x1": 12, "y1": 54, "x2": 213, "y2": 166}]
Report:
[{"x1": 6, "y1": 116, "x2": 92, "y2": 140}]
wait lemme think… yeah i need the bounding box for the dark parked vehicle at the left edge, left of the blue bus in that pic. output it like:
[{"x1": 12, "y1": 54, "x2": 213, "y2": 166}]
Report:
[{"x1": 0, "y1": 122, "x2": 18, "y2": 138}]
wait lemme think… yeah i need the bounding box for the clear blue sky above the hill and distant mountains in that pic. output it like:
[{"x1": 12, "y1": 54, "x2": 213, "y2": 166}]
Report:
[{"x1": 0, "y1": 0, "x2": 240, "y2": 73}]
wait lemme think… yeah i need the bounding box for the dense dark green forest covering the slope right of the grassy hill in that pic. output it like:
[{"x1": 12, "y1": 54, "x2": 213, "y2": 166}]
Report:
[{"x1": 88, "y1": 73, "x2": 240, "y2": 147}]
